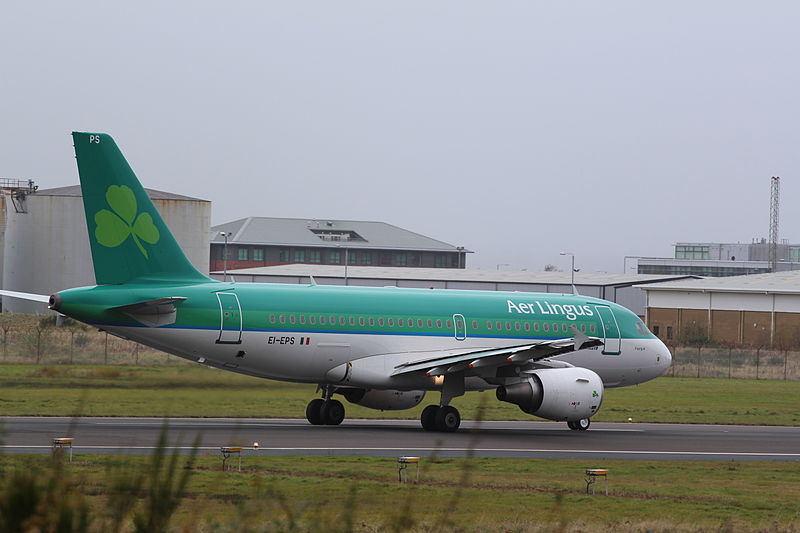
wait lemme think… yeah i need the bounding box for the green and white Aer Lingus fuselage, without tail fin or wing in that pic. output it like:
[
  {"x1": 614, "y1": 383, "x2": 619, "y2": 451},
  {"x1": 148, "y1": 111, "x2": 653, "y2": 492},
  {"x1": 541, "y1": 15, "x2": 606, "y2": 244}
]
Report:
[{"x1": 53, "y1": 282, "x2": 670, "y2": 390}]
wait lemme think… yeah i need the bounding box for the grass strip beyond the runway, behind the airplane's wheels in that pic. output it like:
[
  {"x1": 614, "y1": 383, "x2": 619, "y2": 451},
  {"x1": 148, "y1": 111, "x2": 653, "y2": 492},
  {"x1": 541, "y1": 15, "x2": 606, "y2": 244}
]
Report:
[{"x1": 0, "y1": 364, "x2": 800, "y2": 425}]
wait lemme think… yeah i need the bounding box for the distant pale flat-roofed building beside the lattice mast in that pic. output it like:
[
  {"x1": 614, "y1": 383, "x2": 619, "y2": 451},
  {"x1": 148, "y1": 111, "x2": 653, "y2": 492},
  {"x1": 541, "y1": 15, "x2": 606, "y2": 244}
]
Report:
[{"x1": 631, "y1": 239, "x2": 800, "y2": 277}]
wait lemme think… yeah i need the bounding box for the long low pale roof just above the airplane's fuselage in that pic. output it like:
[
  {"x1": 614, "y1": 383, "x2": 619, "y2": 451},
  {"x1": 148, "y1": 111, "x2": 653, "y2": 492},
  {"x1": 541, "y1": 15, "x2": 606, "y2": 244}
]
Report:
[{"x1": 216, "y1": 264, "x2": 687, "y2": 286}]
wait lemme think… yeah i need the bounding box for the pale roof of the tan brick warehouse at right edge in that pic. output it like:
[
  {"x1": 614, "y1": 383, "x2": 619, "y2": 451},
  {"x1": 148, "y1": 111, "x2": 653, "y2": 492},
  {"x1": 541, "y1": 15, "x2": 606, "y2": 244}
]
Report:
[{"x1": 641, "y1": 270, "x2": 800, "y2": 294}]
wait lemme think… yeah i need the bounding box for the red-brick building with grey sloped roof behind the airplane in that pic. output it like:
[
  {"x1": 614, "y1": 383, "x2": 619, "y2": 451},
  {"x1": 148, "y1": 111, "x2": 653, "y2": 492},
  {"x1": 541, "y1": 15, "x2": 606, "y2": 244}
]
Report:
[{"x1": 210, "y1": 217, "x2": 472, "y2": 271}]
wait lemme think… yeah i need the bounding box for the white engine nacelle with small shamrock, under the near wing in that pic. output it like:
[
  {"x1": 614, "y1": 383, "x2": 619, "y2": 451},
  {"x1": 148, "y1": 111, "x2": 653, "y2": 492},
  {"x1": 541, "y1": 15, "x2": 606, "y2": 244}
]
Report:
[{"x1": 497, "y1": 368, "x2": 603, "y2": 421}]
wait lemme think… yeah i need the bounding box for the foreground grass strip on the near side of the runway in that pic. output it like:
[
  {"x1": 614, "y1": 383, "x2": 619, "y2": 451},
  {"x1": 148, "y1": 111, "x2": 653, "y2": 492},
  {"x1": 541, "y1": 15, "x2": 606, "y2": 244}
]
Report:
[{"x1": 0, "y1": 448, "x2": 800, "y2": 532}]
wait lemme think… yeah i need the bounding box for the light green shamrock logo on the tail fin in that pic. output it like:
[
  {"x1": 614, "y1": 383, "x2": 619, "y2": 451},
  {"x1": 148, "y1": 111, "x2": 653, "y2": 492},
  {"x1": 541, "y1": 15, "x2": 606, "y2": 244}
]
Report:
[{"x1": 94, "y1": 185, "x2": 161, "y2": 258}]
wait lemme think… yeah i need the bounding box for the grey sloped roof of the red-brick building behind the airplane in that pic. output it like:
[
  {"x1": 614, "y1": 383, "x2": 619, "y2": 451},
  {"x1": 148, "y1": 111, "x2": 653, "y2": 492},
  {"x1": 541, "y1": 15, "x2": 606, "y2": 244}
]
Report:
[{"x1": 211, "y1": 217, "x2": 469, "y2": 252}]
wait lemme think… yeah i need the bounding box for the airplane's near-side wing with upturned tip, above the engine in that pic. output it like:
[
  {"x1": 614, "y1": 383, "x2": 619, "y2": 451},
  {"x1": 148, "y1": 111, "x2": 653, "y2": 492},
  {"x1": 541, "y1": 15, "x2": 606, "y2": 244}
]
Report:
[{"x1": 392, "y1": 326, "x2": 603, "y2": 376}]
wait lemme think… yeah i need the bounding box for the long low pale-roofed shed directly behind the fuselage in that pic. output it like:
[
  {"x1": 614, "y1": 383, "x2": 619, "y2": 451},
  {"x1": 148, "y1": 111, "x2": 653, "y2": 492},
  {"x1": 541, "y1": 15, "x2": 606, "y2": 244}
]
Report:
[{"x1": 212, "y1": 264, "x2": 687, "y2": 316}]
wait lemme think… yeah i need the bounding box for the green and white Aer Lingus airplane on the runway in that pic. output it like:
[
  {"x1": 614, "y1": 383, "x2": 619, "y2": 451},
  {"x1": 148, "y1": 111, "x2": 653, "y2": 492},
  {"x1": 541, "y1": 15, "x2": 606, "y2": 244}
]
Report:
[{"x1": 0, "y1": 132, "x2": 672, "y2": 432}]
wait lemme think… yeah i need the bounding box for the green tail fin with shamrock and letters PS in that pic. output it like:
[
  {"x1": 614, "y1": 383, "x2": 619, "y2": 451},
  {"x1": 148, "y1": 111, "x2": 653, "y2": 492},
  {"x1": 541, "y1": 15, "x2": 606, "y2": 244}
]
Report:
[{"x1": 72, "y1": 132, "x2": 210, "y2": 285}]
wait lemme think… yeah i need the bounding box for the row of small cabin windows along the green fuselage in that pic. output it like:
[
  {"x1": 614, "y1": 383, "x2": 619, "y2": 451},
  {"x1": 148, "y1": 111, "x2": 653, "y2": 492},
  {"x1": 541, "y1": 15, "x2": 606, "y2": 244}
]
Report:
[{"x1": 269, "y1": 314, "x2": 597, "y2": 333}]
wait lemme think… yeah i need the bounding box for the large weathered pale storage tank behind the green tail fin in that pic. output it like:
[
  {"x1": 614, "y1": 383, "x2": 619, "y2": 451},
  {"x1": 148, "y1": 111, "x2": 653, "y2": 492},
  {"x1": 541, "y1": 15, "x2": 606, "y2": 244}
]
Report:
[{"x1": 0, "y1": 180, "x2": 211, "y2": 313}]
